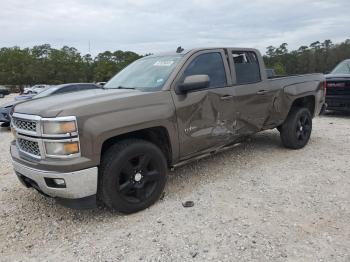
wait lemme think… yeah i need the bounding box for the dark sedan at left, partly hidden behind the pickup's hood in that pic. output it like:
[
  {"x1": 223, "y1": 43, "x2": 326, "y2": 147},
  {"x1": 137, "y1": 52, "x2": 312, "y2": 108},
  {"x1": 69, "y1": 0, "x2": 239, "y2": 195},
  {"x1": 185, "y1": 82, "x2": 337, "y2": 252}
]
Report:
[{"x1": 0, "y1": 83, "x2": 101, "y2": 127}]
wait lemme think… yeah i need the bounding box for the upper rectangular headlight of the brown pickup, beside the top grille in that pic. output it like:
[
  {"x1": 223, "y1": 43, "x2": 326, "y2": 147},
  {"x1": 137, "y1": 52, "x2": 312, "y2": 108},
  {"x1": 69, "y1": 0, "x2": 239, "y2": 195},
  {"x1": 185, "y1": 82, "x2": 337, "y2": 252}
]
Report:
[{"x1": 42, "y1": 118, "x2": 78, "y2": 135}]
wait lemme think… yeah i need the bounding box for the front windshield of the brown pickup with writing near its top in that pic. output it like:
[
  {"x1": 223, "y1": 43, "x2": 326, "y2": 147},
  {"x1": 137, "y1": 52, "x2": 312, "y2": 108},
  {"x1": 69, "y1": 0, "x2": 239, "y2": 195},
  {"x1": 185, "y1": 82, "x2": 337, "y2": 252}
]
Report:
[{"x1": 104, "y1": 55, "x2": 182, "y2": 92}]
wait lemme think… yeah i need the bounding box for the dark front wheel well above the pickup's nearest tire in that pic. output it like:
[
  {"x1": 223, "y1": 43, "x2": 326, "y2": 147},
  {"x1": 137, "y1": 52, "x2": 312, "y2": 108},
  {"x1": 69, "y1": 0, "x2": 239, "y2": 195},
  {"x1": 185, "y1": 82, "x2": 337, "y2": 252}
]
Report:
[{"x1": 101, "y1": 127, "x2": 172, "y2": 166}]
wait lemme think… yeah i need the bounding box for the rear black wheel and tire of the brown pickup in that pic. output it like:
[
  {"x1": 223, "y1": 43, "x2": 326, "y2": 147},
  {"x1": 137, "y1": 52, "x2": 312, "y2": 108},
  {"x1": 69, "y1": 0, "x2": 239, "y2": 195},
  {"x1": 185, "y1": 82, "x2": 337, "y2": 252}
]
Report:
[{"x1": 280, "y1": 108, "x2": 312, "y2": 149}]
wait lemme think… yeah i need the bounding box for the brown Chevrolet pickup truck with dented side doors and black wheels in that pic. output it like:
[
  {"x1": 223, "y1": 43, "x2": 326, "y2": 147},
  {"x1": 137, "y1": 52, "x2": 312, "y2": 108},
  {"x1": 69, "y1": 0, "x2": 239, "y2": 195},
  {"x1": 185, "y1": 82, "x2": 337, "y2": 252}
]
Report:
[{"x1": 11, "y1": 48, "x2": 325, "y2": 213}]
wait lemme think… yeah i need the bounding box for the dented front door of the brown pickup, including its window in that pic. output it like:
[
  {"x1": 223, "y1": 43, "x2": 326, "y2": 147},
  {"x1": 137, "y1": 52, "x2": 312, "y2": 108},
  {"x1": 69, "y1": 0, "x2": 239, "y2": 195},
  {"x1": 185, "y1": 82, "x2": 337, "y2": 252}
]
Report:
[{"x1": 172, "y1": 49, "x2": 234, "y2": 159}]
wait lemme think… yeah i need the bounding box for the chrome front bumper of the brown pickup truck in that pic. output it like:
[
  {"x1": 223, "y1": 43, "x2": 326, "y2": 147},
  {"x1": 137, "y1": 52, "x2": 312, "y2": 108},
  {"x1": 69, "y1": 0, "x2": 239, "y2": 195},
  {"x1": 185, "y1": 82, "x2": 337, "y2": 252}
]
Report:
[{"x1": 12, "y1": 161, "x2": 97, "y2": 199}]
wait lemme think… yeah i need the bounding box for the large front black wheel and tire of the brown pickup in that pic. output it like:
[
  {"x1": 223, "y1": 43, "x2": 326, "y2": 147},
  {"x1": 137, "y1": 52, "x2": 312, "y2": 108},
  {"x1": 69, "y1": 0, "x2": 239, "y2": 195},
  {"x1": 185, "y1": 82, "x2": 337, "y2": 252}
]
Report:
[{"x1": 98, "y1": 139, "x2": 168, "y2": 214}]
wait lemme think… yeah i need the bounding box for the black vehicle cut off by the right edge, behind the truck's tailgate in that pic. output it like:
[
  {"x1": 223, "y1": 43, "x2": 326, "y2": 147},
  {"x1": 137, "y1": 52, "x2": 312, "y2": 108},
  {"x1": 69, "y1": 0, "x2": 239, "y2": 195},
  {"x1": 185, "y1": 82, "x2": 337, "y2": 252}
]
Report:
[{"x1": 326, "y1": 59, "x2": 350, "y2": 111}]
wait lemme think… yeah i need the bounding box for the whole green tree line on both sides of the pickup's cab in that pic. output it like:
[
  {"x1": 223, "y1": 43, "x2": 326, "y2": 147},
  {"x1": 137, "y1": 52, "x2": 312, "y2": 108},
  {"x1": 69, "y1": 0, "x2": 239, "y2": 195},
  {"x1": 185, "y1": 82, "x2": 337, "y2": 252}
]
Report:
[{"x1": 0, "y1": 39, "x2": 350, "y2": 86}]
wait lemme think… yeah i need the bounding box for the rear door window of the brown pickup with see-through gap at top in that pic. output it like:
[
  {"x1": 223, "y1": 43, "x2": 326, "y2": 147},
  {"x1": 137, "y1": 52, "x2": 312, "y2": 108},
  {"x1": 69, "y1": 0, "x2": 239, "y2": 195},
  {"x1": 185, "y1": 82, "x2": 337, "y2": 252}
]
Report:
[{"x1": 232, "y1": 51, "x2": 261, "y2": 85}]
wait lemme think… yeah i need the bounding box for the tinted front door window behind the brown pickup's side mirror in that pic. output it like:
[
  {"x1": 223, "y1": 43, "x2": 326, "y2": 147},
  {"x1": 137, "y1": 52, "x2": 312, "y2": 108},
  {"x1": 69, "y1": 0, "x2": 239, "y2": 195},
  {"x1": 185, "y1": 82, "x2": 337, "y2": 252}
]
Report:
[{"x1": 182, "y1": 52, "x2": 227, "y2": 87}]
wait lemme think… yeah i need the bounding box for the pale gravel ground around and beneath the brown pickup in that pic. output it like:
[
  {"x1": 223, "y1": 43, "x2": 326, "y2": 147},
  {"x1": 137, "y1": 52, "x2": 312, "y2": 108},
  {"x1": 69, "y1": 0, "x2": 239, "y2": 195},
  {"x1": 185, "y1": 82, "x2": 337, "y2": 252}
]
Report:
[{"x1": 0, "y1": 93, "x2": 350, "y2": 261}]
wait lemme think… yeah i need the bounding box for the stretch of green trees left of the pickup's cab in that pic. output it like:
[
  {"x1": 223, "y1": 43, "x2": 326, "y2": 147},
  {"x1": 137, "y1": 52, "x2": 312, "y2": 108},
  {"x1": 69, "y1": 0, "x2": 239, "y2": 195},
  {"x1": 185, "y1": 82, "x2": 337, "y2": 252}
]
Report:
[{"x1": 0, "y1": 44, "x2": 141, "y2": 86}]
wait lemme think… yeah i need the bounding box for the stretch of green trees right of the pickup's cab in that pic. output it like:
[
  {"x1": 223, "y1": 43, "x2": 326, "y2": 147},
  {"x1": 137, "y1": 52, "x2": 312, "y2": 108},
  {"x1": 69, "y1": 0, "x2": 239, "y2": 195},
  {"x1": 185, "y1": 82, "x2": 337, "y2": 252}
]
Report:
[{"x1": 264, "y1": 39, "x2": 350, "y2": 75}]
